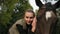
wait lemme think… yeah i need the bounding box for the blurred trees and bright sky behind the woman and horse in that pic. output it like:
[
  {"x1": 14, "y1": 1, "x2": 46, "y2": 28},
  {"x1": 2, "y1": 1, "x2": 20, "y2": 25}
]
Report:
[{"x1": 0, "y1": 0, "x2": 60, "y2": 34}]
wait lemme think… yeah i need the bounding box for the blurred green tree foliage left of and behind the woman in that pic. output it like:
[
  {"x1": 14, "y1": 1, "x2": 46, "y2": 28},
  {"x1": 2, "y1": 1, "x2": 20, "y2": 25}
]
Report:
[{"x1": 0, "y1": 0, "x2": 32, "y2": 34}]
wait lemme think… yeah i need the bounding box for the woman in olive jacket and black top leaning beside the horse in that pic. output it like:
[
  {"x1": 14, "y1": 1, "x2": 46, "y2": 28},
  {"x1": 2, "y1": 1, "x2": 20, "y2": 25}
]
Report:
[{"x1": 9, "y1": 10, "x2": 37, "y2": 34}]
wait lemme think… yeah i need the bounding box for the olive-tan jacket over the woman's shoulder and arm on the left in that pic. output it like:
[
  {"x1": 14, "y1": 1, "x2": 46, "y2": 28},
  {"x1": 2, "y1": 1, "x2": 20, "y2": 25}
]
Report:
[{"x1": 9, "y1": 19, "x2": 26, "y2": 34}]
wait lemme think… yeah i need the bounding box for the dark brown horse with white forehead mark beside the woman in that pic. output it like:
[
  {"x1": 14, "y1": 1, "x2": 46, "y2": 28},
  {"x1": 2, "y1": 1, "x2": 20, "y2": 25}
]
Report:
[{"x1": 35, "y1": 0, "x2": 60, "y2": 34}]
